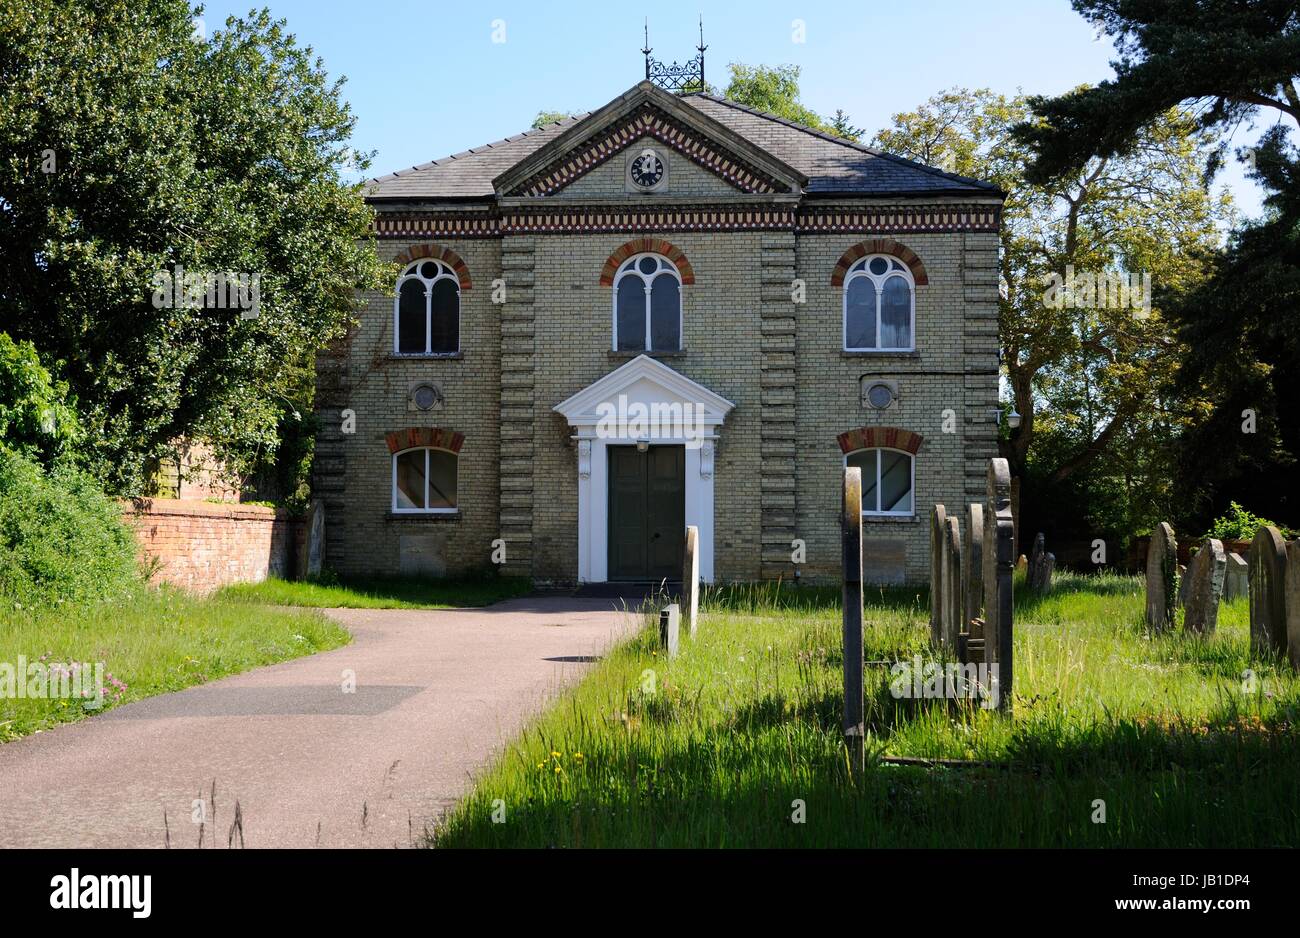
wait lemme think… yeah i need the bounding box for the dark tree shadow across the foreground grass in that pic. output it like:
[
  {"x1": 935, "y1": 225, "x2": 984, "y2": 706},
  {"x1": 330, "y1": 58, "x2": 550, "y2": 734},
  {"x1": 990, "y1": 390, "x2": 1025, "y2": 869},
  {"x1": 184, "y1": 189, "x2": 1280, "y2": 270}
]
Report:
[{"x1": 437, "y1": 698, "x2": 1300, "y2": 847}]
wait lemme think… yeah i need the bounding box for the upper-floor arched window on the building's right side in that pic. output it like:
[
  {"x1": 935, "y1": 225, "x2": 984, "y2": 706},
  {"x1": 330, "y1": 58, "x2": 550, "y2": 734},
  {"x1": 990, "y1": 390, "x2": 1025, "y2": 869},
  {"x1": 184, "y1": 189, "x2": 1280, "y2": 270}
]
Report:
[{"x1": 844, "y1": 255, "x2": 917, "y2": 352}]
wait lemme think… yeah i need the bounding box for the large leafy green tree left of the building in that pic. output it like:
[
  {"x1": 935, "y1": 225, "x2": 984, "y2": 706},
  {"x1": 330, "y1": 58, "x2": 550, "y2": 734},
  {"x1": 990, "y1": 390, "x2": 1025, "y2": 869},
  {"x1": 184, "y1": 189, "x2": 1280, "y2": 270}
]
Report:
[{"x1": 0, "y1": 0, "x2": 382, "y2": 492}]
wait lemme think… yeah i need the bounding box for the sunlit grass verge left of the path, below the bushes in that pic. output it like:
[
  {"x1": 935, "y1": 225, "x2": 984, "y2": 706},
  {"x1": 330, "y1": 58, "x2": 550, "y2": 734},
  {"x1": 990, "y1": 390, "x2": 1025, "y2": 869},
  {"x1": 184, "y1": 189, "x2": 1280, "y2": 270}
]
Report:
[{"x1": 0, "y1": 590, "x2": 351, "y2": 742}]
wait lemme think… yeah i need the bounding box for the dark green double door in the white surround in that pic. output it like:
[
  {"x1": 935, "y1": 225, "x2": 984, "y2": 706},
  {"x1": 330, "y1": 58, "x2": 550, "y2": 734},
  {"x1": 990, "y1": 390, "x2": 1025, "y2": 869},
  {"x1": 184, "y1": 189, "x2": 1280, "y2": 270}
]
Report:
[{"x1": 606, "y1": 446, "x2": 686, "y2": 581}]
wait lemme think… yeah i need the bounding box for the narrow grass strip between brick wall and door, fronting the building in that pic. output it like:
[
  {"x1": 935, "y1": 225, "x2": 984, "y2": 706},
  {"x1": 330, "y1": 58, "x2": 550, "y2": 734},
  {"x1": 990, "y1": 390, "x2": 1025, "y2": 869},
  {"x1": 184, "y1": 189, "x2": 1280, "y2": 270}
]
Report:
[{"x1": 218, "y1": 577, "x2": 532, "y2": 609}]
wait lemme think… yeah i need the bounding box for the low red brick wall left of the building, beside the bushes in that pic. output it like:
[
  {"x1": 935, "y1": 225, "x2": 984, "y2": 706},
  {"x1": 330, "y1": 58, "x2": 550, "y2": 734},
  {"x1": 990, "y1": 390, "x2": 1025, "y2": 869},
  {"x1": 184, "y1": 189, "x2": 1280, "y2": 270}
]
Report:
[{"x1": 126, "y1": 499, "x2": 302, "y2": 592}]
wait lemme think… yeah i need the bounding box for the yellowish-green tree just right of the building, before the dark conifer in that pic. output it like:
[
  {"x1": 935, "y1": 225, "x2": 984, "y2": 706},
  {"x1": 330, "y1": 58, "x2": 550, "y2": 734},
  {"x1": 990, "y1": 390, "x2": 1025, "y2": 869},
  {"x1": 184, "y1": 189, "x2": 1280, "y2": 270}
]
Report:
[{"x1": 874, "y1": 88, "x2": 1229, "y2": 540}]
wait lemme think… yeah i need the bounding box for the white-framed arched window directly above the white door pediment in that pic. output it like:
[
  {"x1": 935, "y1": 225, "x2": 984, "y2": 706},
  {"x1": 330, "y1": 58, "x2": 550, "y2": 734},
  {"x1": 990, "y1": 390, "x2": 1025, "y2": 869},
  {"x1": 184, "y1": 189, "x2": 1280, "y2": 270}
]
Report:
[{"x1": 614, "y1": 255, "x2": 681, "y2": 352}]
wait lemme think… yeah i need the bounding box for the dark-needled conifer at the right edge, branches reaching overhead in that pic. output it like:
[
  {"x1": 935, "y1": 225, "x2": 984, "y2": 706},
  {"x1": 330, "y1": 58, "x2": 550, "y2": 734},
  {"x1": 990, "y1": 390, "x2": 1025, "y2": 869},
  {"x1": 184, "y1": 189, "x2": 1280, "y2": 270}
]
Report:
[{"x1": 1017, "y1": 0, "x2": 1300, "y2": 524}]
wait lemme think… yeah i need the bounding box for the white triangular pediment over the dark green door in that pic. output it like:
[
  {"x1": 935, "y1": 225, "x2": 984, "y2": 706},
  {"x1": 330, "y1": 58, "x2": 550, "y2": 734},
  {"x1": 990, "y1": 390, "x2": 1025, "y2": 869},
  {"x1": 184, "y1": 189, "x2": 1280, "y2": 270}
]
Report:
[{"x1": 553, "y1": 355, "x2": 736, "y2": 426}]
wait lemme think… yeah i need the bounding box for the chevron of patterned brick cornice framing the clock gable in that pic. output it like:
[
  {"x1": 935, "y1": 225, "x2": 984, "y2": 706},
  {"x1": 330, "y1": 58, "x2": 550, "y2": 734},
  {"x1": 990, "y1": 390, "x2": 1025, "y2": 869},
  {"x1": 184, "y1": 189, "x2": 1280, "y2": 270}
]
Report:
[{"x1": 493, "y1": 82, "x2": 807, "y2": 199}]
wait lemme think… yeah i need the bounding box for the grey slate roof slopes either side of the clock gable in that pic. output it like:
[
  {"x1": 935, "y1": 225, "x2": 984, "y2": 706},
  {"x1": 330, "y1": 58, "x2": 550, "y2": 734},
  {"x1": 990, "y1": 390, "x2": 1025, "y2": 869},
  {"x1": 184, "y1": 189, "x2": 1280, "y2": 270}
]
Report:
[{"x1": 368, "y1": 94, "x2": 1002, "y2": 201}]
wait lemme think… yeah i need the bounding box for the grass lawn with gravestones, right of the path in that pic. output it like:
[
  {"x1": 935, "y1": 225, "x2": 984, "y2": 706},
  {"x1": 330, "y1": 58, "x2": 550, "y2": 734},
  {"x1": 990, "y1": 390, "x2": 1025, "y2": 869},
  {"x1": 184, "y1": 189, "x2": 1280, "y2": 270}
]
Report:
[{"x1": 433, "y1": 573, "x2": 1300, "y2": 847}]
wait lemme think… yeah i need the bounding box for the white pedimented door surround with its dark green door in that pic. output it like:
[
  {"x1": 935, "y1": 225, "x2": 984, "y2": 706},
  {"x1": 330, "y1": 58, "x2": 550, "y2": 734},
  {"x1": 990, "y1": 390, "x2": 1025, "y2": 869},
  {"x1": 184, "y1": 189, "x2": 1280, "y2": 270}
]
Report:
[{"x1": 554, "y1": 355, "x2": 735, "y2": 583}]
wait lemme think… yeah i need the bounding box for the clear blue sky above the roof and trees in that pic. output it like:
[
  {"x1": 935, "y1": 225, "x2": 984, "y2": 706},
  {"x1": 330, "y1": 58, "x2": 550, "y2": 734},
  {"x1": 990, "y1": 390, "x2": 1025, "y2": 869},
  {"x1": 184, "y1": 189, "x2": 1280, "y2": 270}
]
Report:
[{"x1": 195, "y1": 0, "x2": 1277, "y2": 214}]
